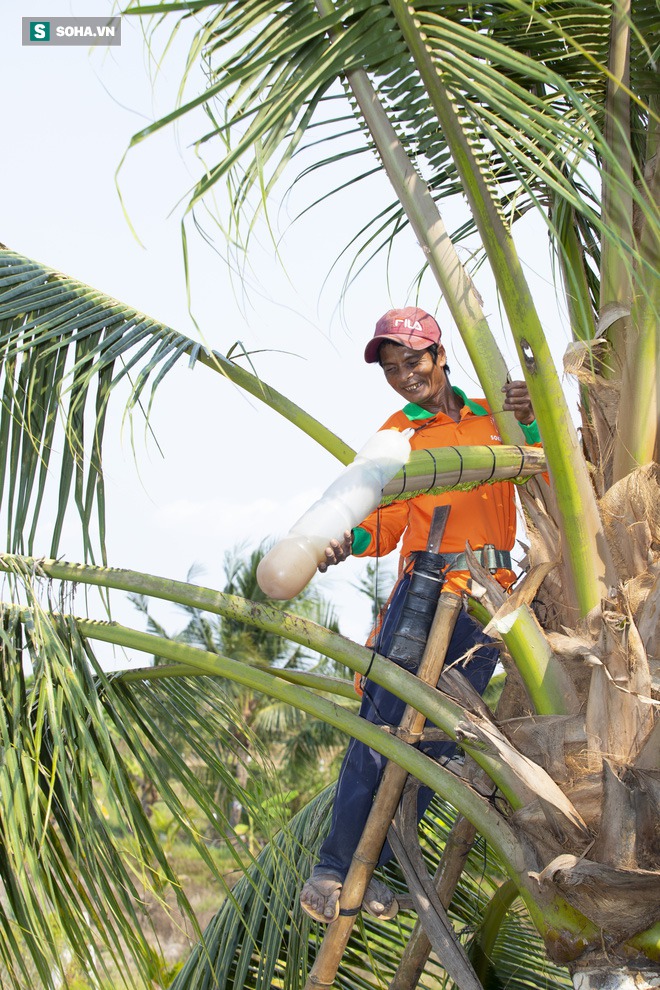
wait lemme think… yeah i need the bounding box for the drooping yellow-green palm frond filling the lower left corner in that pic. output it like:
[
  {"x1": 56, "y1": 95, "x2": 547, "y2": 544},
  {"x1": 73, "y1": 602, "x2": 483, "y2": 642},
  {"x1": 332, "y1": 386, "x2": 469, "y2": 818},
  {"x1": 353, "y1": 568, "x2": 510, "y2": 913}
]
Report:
[{"x1": 0, "y1": 568, "x2": 302, "y2": 988}]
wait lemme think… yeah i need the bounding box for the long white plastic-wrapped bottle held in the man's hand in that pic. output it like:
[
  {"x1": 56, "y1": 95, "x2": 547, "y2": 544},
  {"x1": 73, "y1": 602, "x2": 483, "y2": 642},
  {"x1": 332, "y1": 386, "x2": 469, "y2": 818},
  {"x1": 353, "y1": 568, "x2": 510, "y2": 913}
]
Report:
[{"x1": 257, "y1": 430, "x2": 413, "y2": 601}]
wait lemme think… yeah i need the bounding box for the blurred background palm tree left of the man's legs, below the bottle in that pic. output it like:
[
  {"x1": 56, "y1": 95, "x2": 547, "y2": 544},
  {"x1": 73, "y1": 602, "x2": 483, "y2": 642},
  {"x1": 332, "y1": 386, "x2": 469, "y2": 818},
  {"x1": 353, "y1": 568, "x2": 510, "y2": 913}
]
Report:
[{"x1": 130, "y1": 544, "x2": 345, "y2": 839}]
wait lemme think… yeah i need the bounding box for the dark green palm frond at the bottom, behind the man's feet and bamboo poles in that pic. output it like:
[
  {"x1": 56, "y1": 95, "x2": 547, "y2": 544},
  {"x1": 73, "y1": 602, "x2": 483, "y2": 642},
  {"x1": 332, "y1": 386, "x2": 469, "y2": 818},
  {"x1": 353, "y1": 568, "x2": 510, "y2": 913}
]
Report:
[{"x1": 173, "y1": 788, "x2": 571, "y2": 990}]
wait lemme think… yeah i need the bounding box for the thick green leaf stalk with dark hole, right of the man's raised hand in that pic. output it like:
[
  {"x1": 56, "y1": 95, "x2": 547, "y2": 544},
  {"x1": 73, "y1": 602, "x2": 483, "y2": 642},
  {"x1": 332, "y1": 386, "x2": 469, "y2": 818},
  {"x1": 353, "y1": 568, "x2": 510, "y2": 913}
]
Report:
[{"x1": 389, "y1": 0, "x2": 614, "y2": 615}]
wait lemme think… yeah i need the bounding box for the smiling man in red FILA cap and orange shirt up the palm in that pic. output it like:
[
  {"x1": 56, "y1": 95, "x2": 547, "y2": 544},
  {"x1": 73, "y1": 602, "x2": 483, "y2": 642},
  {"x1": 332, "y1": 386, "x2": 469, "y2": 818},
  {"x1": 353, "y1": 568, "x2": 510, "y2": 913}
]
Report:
[{"x1": 300, "y1": 307, "x2": 539, "y2": 923}]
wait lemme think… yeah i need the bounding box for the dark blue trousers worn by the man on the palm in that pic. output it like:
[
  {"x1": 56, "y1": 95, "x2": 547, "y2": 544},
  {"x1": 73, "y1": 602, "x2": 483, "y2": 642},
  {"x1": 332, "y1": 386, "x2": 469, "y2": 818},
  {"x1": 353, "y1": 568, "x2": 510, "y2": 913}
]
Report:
[{"x1": 315, "y1": 575, "x2": 498, "y2": 878}]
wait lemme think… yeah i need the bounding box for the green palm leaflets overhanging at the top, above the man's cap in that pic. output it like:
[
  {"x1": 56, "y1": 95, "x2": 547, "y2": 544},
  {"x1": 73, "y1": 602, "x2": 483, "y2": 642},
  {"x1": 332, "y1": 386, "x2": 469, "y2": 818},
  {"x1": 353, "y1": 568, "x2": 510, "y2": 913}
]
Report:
[{"x1": 126, "y1": 0, "x2": 660, "y2": 290}]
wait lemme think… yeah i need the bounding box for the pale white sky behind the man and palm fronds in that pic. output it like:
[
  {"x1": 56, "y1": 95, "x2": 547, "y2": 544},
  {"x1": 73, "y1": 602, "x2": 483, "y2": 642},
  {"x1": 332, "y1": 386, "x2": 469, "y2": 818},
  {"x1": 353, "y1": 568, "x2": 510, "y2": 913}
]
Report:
[{"x1": 0, "y1": 0, "x2": 568, "y2": 664}]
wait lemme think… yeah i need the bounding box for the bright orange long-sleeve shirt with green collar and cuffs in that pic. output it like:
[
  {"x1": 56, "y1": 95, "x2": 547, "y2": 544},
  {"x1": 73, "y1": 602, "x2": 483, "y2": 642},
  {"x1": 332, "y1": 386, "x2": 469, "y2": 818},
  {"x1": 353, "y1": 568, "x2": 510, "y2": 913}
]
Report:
[{"x1": 353, "y1": 388, "x2": 539, "y2": 592}]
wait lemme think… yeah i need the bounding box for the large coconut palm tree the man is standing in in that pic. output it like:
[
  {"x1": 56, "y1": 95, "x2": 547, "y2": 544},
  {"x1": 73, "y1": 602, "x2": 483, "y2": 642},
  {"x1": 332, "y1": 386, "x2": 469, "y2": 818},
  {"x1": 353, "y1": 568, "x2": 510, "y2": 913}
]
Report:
[{"x1": 0, "y1": 0, "x2": 660, "y2": 988}]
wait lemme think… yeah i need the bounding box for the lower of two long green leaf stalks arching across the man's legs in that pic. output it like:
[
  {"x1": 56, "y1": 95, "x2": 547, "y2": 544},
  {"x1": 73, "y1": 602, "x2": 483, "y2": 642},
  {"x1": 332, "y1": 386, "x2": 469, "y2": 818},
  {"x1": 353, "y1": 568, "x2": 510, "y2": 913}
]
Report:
[{"x1": 2, "y1": 592, "x2": 596, "y2": 956}]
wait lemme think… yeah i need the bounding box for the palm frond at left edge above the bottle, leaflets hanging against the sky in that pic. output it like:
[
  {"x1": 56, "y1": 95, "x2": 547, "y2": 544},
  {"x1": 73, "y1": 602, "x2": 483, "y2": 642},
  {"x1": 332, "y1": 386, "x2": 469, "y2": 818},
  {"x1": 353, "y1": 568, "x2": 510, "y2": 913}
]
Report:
[{"x1": 0, "y1": 249, "x2": 353, "y2": 558}]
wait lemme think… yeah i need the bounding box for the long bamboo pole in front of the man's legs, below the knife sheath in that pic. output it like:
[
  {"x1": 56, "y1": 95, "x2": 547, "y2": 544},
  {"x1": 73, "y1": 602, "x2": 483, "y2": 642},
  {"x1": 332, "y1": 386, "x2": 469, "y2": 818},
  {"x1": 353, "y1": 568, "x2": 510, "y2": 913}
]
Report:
[{"x1": 305, "y1": 592, "x2": 462, "y2": 990}]
